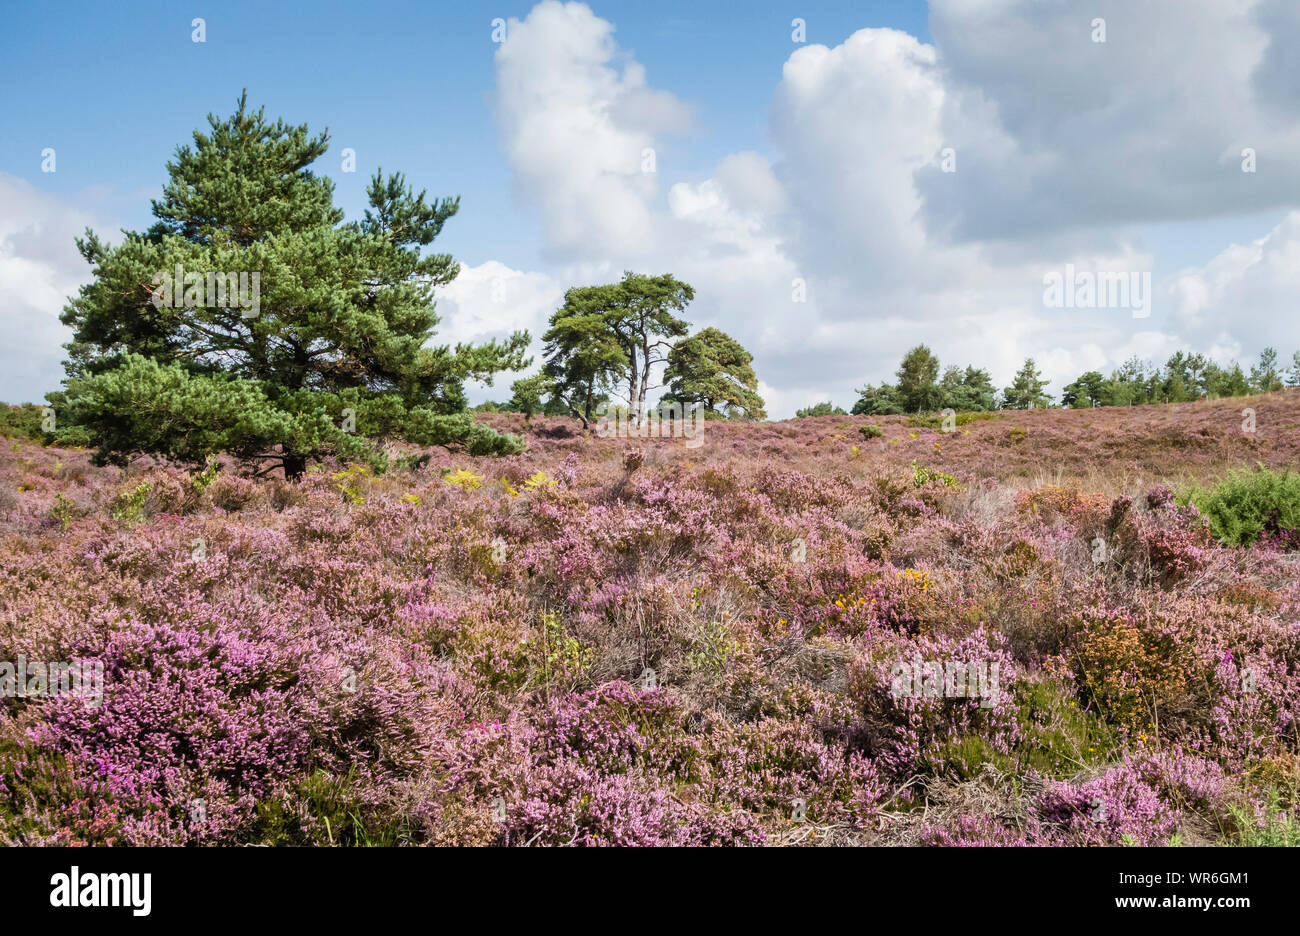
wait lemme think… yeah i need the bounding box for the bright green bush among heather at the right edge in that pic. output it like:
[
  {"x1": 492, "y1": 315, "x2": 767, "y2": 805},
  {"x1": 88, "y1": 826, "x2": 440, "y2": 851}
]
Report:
[{"x1": 1179, "y1": 465, "x2": 1300, "y2": 546}]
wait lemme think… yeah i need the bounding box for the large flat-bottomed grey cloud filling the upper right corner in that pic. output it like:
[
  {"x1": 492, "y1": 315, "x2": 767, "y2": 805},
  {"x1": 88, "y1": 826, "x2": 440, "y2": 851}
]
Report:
[{"x1": 919, "y1": 0, "x2": 1300, "y2": 239}]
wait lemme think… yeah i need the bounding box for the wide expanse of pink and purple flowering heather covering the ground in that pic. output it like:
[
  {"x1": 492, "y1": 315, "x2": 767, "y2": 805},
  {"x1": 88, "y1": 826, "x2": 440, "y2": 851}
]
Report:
[{"x1": 0, "y1": 393, "x2": 1300, "y2": 846}]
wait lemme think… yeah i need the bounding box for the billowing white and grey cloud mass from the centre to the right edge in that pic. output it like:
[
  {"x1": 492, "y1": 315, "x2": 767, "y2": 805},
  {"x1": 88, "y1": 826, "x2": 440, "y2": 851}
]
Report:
[{"x1": 473, "y1": 0, "x2": 1300, "y2": 416}]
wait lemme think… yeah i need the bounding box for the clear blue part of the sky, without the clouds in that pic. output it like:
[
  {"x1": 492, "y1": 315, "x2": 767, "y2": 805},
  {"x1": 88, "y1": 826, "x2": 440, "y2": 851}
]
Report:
[{"x1": 0, "y1": 0, "x2": 927, "y2": 265}]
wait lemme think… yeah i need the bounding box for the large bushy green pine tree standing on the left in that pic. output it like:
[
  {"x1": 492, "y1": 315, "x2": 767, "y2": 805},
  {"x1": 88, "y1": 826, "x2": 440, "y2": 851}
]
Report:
[{"x1": 49, "y1": 95, "x2": 529, "y2": 476}]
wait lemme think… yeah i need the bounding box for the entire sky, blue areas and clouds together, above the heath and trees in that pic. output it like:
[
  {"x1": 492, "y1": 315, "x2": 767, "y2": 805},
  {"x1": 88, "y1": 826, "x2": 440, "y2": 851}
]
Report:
[{"x1": 0, "y1": 0, "x2": 1300, "y2": 417}]
